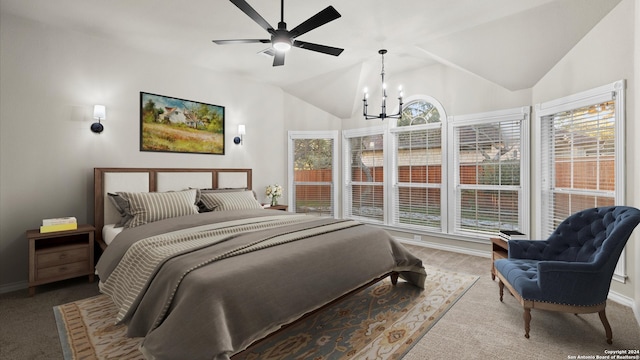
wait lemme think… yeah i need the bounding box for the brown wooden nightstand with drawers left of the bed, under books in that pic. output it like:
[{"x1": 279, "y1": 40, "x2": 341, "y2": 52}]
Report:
[{"x1": 27, "y1": 225, "x2": 95, "y2": 296}]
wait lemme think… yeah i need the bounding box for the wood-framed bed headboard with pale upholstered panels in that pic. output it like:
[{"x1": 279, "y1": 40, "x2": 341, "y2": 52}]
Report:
[{"x1": 93, "y1": 168, "x2": 252, "y2": 246}]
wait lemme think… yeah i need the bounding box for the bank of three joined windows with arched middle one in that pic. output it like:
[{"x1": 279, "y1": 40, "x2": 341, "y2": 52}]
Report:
[{"x1": 343, "y1": 95, "x2": 531, "y2": 241}]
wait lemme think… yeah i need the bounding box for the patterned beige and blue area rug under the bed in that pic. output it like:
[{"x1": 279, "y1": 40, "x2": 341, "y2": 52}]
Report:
[{"x1": 53, "y1": 266, "x2": 478, "y2": 360}]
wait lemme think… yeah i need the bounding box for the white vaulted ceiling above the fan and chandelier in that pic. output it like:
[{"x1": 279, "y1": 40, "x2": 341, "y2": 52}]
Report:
[{"x1": 0, "y1": 0, "x2": 621, "y2": 118}]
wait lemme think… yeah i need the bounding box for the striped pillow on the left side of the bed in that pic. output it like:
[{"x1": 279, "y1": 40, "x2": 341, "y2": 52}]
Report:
[{"x1": 117, "y1": 189, "x2": 198, "y2": 228}]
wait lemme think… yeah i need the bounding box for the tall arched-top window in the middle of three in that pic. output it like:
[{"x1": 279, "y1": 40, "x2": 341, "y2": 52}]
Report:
[{"x1": 390, "y1": 99, "x2": 446, "y2": 231}]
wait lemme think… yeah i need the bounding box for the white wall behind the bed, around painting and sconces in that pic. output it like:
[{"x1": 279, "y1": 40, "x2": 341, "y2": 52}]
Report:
[{"x1": 0, "y1": 14, "x2": 318, "y2": 292}]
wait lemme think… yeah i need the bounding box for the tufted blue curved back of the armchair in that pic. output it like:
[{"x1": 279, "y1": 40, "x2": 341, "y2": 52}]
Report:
[{"x1": 541, "y1": 206, "x2": 640, "y2": 267}]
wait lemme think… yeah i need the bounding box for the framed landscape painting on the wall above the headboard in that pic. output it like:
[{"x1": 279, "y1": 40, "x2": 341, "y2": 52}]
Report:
[{"x1": 140, "y1": 92, "x2": 224, "y2": 155}]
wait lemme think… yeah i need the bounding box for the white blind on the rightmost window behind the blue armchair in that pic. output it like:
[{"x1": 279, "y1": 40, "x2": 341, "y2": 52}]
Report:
[{"x1": 541, "y1": 100, "x2": 616, "y2": 238}]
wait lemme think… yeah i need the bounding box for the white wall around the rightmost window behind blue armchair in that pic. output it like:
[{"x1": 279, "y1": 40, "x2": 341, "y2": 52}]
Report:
[{"x1": 531, "y1": 0, "x2": 640, "y2": 300}]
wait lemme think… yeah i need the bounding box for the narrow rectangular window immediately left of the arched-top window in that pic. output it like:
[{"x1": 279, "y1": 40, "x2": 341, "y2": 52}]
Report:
[{"x1": 343, "y1": 128, "x2": 386, "y2": 223}]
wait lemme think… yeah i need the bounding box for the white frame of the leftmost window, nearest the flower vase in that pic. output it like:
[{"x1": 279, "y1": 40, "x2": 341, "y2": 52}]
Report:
[{"x1": 287, "y1": 130, "x2": 340, "y2": 219}]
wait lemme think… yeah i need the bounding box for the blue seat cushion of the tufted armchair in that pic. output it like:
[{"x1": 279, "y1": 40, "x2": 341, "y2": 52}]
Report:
[{"x1": 495, "y1": 259, "x2": 543, "y2": 301}]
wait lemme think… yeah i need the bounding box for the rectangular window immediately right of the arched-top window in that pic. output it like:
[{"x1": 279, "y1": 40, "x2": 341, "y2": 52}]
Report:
[{"x1": 449, "y1": 107, "x2": 531, "y2": 235}]
